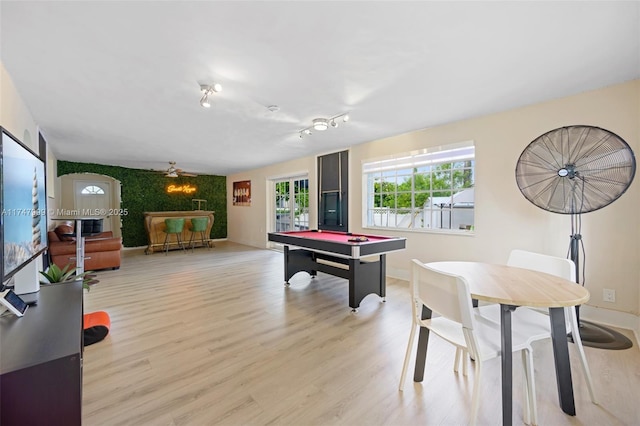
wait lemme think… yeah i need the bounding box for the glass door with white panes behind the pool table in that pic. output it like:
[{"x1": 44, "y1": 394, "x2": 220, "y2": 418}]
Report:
[{"x1": 273, "y1": 177, "x2": 309, "y2": 232}]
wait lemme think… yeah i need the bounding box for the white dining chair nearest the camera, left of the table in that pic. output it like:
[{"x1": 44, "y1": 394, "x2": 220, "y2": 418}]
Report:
[{"x1": 399, "y1": 259, "x2": 537, "y2": 424}]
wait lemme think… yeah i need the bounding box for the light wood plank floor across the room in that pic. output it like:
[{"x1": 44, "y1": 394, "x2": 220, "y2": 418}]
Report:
[{"x1": 83, "y1": 242, "x2": 640, "y2": 426}]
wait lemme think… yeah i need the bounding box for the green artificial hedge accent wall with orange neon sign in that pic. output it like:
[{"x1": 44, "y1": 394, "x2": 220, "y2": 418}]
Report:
[{"x1": 58, "y1": 161, "x2": 227, "y2": 247}]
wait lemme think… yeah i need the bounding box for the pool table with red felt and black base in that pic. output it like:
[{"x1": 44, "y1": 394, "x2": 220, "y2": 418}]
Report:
[{"x1": 268, "y1": 230, "x2": 406, "y2": 312}]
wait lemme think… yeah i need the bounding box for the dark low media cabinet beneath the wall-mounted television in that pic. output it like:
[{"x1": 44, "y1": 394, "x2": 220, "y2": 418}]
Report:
[{"x1": 0, "y1": 281, "x2": 83, "y2": 426}]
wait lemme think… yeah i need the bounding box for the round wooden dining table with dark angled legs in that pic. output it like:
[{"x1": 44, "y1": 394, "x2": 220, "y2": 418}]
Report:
[{"x1": 414, "y1": 262, "x2": 589, "y2": 425}]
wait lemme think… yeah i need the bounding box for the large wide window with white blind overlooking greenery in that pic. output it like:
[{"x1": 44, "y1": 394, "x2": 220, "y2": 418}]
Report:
[{"x1": 362, "y1": 142, "x2": 475, "y2": 232}]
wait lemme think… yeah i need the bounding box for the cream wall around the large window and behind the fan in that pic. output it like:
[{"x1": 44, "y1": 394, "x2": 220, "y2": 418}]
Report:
[{"x1": 227, "y1": 80, "x2": 640, "y2": 322}]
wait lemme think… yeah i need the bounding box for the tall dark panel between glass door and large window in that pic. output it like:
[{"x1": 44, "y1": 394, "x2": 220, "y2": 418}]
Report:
[{"x1": 318, "y1": 151, "x2": 349, "y2": 232}]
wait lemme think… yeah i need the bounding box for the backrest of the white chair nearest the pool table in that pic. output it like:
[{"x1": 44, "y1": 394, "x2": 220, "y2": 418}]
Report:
[{"x1": 410, "y1": 259, "x2": 473, "y2": 330}]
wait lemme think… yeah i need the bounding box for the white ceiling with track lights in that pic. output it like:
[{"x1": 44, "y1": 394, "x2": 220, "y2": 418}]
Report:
[{"x1": 0, "y1": 0, "x2": 640, "y2": 175}]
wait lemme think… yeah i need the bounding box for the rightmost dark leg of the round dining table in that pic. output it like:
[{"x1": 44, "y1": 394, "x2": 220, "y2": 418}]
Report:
[{"x1": 549, "y1": 308, "x2": 576, "y2": 416}]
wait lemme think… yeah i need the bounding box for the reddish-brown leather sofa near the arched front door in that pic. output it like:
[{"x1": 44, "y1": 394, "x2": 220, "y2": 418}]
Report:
[{"x1": 47, "y1": 223, "x2": 122, "y2": 271}]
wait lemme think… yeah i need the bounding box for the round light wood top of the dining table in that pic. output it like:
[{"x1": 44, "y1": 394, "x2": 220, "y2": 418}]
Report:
[{"x1": 426, "y1": 262, "x2": 590, "y2": 308}]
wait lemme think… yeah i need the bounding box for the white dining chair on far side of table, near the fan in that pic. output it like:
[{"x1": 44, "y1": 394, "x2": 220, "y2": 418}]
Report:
[{"x1": 477, "y1": 250, "x2": 598, "y2": 410}]
